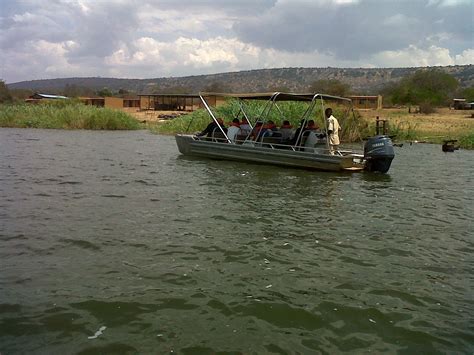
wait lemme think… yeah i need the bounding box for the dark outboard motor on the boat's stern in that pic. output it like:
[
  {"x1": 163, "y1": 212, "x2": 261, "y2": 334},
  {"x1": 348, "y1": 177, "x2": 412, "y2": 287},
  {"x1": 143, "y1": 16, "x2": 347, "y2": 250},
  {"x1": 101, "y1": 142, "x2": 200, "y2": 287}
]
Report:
[{"x1": 364, "y1": 135, "x2": 395, "y2": 173}]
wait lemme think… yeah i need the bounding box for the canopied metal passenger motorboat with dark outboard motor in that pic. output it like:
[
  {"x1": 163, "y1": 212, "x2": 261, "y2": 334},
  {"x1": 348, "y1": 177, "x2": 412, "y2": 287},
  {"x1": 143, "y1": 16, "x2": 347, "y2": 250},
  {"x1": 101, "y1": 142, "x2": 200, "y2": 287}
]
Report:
[{"x1": 176, "y1": 92, "x2": 394, "y2": 173}]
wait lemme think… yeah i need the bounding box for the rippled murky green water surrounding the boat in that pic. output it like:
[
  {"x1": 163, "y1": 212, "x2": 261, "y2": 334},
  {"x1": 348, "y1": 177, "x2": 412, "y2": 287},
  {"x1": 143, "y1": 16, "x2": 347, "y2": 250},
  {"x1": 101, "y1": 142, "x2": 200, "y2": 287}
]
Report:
[{"x1": 0, "y1": 129, "x2": 474, "y2": 354}]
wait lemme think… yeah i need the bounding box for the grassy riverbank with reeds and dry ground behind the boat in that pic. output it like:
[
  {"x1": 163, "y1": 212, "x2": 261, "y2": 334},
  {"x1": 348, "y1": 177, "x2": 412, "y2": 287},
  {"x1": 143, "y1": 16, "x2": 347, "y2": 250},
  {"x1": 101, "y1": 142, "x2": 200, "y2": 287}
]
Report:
[{"x1": 0, "y1": 103, "x2": 474, "y2": 149}]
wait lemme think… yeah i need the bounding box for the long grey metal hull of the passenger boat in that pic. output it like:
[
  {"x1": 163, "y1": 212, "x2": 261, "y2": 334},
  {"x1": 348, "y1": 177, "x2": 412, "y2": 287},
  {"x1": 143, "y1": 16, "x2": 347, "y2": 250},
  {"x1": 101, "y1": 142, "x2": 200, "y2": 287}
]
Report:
[{"x1": 176, "y1": 134, "x2": 364, "y2": 171}]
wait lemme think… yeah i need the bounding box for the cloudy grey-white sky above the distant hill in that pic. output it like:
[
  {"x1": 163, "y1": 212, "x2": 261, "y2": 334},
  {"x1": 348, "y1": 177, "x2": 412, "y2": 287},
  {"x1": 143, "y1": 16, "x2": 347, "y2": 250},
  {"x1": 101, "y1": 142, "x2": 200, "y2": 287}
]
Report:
[{"x1": 0, "y1": 0, "x2": 474, "y2": 83}]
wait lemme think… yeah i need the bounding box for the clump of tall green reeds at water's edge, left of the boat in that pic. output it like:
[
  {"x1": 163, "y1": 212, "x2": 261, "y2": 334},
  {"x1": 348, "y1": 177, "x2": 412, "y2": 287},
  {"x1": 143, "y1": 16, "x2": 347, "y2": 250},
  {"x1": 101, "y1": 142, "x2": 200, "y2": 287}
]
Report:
[{"x1": 0, "y1": 101, "x2": 140, "y2": 130}]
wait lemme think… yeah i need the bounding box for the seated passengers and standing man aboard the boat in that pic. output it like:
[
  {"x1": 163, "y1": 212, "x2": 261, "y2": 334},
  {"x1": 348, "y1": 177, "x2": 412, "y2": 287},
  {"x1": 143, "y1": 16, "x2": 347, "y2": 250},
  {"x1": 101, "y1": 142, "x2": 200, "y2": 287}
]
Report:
[{"x1": 197, "y1": 108, "x2": 340, "y2": 151}]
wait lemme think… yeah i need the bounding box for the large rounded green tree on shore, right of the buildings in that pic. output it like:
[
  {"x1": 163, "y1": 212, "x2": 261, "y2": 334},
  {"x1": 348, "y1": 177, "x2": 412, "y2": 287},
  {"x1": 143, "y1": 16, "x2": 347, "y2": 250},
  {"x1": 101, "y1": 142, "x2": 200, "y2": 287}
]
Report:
[{"x1": 389, "y1": 69, "x2": 459, "y2": 106}]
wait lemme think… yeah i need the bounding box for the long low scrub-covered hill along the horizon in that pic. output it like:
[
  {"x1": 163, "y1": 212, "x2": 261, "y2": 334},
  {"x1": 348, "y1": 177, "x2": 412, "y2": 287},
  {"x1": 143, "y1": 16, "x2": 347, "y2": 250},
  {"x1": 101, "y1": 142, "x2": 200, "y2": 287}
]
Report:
[{"x1": 8, "y1": 65, "x2": 474, "y2": 94}]
